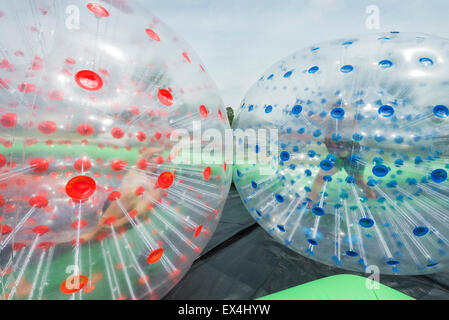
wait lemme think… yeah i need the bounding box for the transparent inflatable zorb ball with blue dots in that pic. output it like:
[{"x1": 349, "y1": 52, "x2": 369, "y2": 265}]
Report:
[{"x1": 234, "y1": 32, "x2": 449, "y2": 274}]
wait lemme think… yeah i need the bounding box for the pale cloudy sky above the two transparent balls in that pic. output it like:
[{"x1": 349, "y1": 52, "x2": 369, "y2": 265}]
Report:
[{"x1": 142, "y1": 0, "x2": 449, "y2": 108}]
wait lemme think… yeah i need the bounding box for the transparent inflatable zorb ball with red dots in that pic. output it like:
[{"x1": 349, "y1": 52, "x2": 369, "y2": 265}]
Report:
[{"x1": 0, "y1": 0, "x2": 231, "y2": 299}]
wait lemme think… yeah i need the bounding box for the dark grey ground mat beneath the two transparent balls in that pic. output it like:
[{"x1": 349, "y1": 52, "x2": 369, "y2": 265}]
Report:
[{"x1": 165, "y1": 187, "x2": 449, "y2": 300}]
